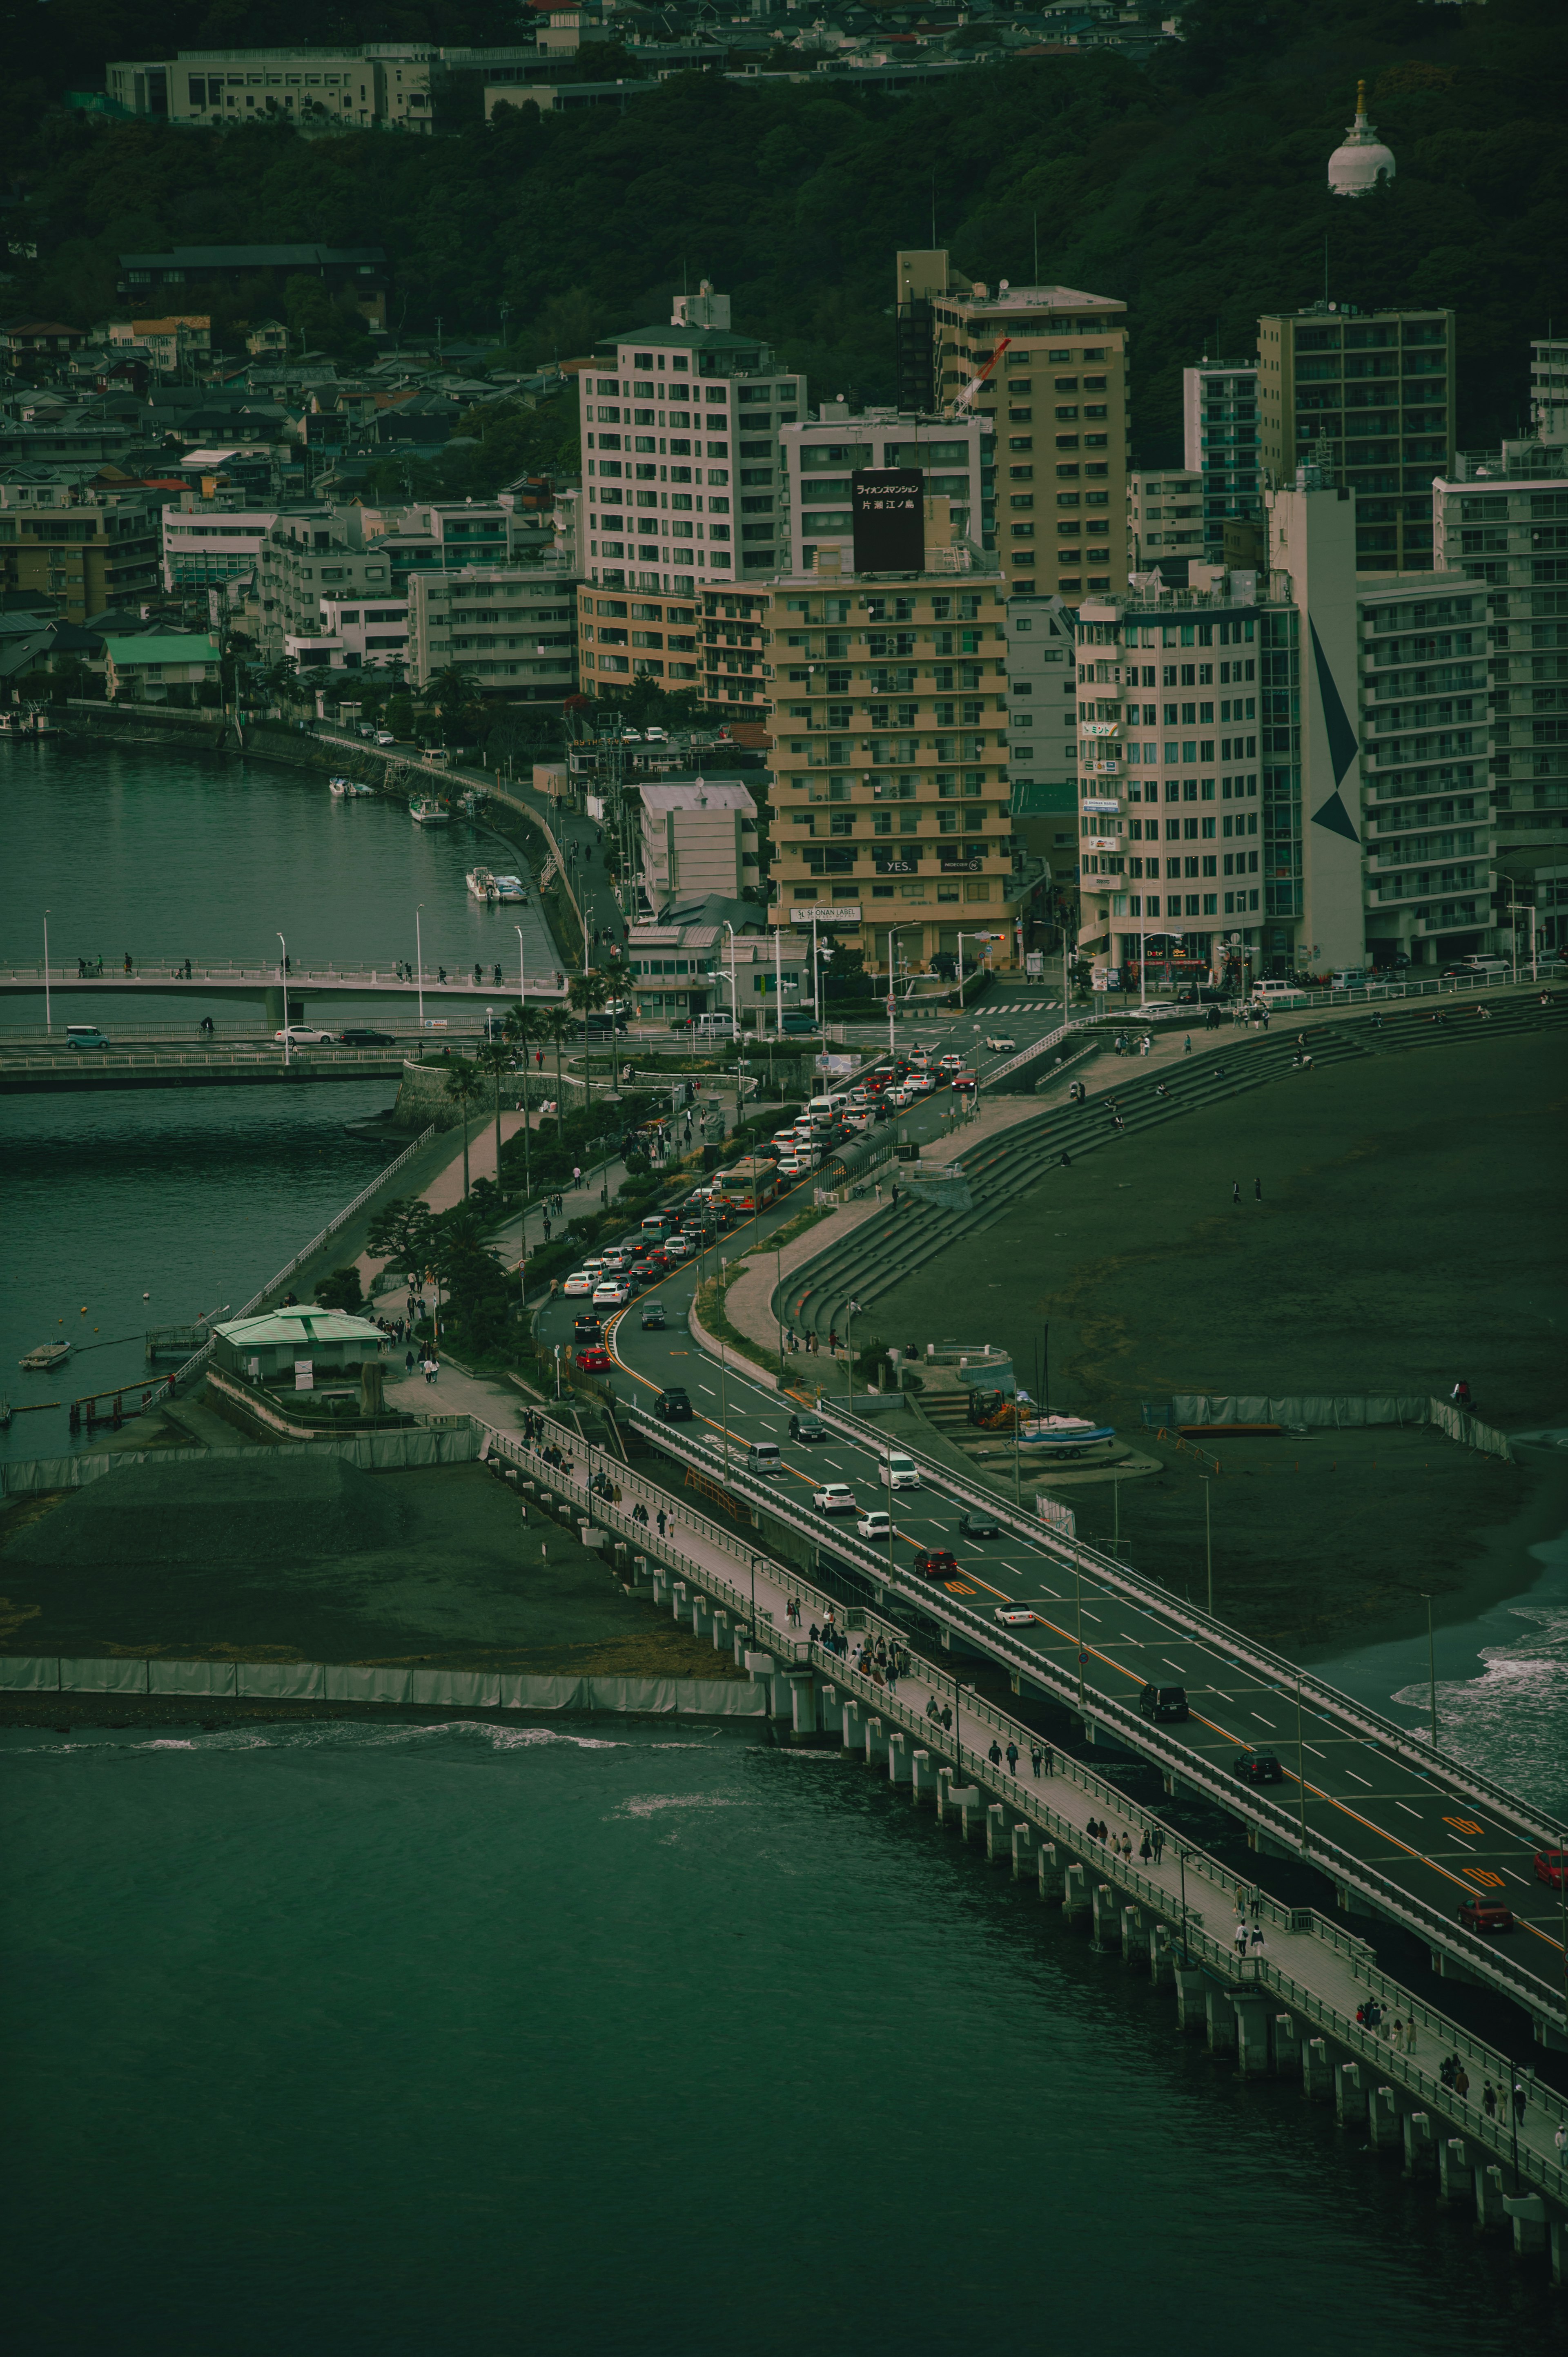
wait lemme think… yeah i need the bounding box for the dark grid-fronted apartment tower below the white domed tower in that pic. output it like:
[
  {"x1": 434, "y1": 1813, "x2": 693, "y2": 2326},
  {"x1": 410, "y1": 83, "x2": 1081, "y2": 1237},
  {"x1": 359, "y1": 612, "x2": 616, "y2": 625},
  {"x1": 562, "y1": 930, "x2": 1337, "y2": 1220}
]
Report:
[{"x1": 1257, "y1": 304, "x2": 1455, "y2": 573}]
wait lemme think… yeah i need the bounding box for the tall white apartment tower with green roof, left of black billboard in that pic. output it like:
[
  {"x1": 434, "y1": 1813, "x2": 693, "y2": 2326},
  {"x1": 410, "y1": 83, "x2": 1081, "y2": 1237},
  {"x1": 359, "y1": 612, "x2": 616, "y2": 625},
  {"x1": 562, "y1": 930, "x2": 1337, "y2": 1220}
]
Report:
[{"x1": 578, "y1": 285, "x2": 806, "y2": 599}]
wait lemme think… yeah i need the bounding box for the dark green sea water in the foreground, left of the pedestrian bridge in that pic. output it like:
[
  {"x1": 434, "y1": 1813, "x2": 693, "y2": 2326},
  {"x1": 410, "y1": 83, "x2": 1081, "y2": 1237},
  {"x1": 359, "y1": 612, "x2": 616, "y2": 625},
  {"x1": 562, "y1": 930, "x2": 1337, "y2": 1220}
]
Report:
[{"x1": 0, "y1": 1723, "x2": 1554, "y2": 2357}]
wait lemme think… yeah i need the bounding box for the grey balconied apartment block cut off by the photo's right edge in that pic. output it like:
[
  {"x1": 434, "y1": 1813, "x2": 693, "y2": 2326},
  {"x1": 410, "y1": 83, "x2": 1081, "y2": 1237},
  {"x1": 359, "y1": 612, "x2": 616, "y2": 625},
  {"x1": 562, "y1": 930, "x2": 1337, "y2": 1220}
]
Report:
[{"x1": 1429, "y1": 438, "x2": 1568, "y2": 950}]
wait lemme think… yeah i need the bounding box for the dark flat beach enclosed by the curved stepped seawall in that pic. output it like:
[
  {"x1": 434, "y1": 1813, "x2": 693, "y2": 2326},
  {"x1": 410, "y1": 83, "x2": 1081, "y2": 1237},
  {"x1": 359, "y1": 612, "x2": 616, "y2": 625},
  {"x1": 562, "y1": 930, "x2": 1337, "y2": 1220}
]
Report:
[{"x1": 877, "y1": 1037, "x2": 1568, "y2": 1645}]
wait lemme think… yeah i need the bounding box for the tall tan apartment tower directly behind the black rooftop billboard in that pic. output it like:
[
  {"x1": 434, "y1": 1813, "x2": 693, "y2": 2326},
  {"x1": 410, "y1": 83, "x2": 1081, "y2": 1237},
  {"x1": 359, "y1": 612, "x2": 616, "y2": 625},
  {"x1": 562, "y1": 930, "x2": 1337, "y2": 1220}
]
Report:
[{"x1": 898, "y1": 252, "x2": 1129, "y2": 601}]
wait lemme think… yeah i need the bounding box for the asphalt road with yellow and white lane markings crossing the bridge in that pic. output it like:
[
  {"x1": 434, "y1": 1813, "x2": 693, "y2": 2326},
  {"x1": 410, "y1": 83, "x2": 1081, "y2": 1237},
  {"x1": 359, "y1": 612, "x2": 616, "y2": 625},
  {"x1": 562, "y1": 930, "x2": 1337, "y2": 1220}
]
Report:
[{"x1": 528, "y1": 1136, "x2": 1563, "y2": 1991}]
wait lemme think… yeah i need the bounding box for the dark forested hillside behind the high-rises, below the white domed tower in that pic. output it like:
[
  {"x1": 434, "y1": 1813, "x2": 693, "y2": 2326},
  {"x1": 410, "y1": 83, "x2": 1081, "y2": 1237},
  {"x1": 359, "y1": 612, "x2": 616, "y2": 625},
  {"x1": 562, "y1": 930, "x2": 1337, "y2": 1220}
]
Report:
[{"x1": 0, "y1": 0, "x2": 1568, "y2": 459}]
